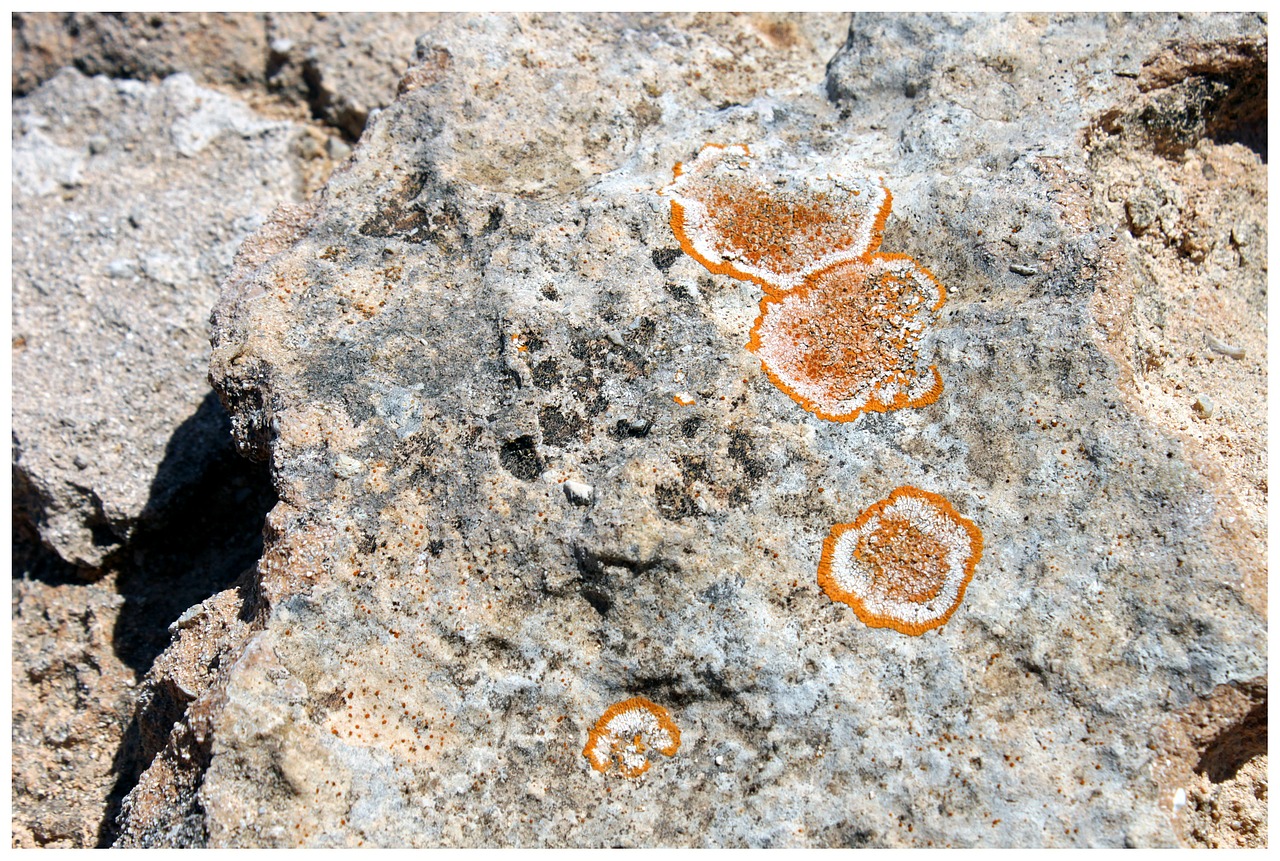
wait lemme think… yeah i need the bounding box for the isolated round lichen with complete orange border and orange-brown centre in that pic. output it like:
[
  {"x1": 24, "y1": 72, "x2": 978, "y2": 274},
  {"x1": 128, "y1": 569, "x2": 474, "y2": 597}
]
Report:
[{"x1": 818, "y1": 487, "x2": 982, "y2": 636}]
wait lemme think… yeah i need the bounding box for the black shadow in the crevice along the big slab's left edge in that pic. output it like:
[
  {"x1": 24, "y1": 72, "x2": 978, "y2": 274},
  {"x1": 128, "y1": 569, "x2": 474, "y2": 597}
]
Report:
[{"x1": 99, "y1": 391, "x2": 276, "y2": 847}]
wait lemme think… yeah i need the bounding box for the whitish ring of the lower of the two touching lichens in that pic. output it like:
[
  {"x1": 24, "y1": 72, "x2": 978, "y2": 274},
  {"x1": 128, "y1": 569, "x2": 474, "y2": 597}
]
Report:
[{"x1": 753, "y1": 255, "x2": 942, "y2": 416}]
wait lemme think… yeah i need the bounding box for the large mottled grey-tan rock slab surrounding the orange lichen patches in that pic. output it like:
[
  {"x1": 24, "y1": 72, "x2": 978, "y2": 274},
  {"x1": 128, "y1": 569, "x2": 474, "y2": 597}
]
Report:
[{"x1": 118, "y1": 15, "x2": 1266, "y2": 847}]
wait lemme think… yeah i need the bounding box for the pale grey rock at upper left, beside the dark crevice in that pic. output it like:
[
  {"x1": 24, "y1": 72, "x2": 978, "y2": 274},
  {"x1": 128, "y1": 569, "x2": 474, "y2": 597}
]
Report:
[{"x1": 13, "y1": 70, "x2": 302, "y2": 568}]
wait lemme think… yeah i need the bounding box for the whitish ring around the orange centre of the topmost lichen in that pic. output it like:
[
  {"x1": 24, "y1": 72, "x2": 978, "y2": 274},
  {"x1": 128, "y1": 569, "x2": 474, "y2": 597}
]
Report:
[{"x1": 659, "y1": 143, "x2": 890, "y2": 293}]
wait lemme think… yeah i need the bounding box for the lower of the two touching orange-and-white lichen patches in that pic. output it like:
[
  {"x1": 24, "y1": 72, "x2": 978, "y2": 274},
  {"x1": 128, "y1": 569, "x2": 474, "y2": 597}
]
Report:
[{"x1": 746, "y1": 255, "x2": 946, "y2": 421}]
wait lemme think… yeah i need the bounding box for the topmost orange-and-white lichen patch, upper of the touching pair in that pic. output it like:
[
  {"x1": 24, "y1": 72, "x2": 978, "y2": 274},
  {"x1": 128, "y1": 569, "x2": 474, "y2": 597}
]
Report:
[{"x1": 660, "y1": 143, "x2": 893, "y2": 294}]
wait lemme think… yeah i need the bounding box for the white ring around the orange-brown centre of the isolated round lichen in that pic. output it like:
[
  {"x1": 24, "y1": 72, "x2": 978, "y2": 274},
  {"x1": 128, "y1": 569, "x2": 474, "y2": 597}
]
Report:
[{"x1": 831, "y1": 494, "x2": 974, "y2": 628}]
